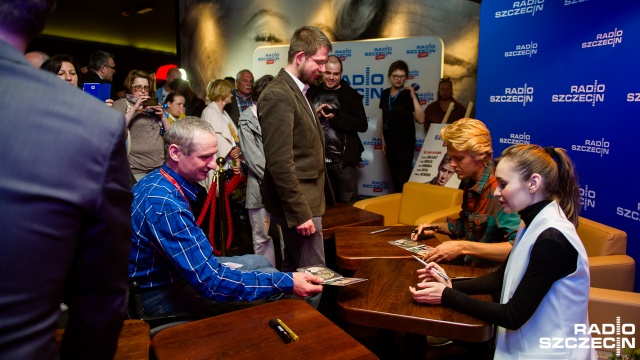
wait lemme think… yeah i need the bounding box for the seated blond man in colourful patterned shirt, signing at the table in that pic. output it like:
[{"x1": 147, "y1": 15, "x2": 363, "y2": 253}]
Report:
[{"x1": 412, "y1": 118, "x2": 520, "y2": 267}]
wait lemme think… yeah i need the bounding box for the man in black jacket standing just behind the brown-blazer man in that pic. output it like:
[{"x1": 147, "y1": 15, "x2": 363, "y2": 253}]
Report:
[{"x1": 307, "y1": 55, "x2": 368, "y2": 205}]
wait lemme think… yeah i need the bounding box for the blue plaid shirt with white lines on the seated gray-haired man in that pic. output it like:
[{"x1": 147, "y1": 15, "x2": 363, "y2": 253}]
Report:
[{"x1": 129, "y1": 164, "x2": 293, "y2": 301}]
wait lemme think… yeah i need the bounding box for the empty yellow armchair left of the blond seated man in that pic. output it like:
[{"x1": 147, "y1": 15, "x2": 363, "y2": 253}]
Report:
[{"x1": 353, "y1": 182, "x2": 462, "y2": 226}]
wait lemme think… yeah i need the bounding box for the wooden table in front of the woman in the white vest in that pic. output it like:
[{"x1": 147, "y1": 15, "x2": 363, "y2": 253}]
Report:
[{"x1": 338, "y1": 259, "x2": 493, "y2": 342}]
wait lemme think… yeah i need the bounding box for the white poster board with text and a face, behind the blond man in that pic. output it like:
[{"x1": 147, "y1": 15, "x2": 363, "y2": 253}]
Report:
[{"x1": 409, "y1": 124, "x2": 460, "y2": 189}]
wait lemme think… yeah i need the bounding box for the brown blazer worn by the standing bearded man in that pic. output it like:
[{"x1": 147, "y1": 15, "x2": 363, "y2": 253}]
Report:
[{"x1": 258, "y1": 69, "x2": 331, "y2": 227}]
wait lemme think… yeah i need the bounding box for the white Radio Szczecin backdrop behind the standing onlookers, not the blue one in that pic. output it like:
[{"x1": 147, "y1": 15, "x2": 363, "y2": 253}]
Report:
[{"x1": 253, "y1": 36, "x2": 444, "y2": 196}]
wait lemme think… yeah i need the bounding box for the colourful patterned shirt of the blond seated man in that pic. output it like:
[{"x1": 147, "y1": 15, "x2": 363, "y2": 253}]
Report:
[{"x1": 448, "y1": 162, "x2": 520, "y2": 266}]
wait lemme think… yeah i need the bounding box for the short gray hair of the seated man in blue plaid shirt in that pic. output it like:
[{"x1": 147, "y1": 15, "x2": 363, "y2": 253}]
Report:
[{"x1": 164, "y1": 116, "x2": 215, "y2": 160}]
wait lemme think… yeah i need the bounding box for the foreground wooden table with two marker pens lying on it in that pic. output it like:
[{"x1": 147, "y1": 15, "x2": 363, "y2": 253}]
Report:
[{"x1": 153, "y1": 299, "x2": 376, "y2": 360}]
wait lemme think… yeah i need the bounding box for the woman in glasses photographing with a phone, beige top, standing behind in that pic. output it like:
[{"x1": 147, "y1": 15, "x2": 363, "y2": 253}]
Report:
[{"x1": 113, "y1": 70, "x2": 171, "y2": 181}]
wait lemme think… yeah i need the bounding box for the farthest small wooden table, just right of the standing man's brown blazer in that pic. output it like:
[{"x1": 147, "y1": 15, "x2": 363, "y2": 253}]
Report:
[{"x1": 322, "y1": 204, "x2": 384, "y2": 240}]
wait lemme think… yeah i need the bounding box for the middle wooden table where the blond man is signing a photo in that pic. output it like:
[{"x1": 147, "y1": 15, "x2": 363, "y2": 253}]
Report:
[{"x1": 335, "y1": 226, "x2": 440, "y2": 270}]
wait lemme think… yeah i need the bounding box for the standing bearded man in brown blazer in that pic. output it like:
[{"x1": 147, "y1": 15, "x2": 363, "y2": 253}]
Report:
[{"x1": 258, "y1": 26, "x2": 332, "y2": 271}]
